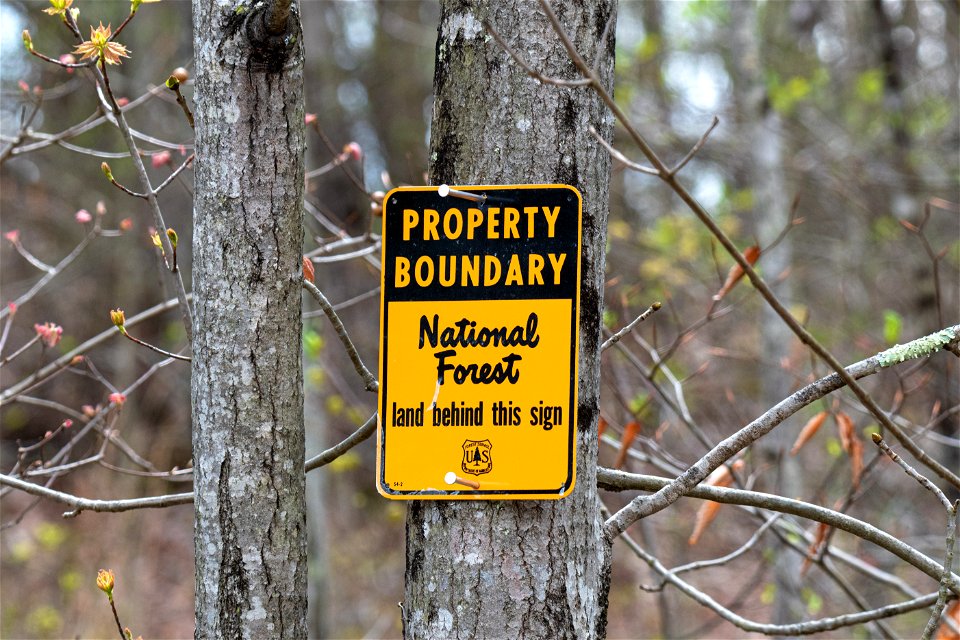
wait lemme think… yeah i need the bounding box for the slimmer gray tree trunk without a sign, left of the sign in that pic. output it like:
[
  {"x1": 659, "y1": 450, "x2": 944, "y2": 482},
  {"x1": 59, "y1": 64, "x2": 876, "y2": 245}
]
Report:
[{"x1": 192, "y1": 0, "x2": 307, "y2": 638}]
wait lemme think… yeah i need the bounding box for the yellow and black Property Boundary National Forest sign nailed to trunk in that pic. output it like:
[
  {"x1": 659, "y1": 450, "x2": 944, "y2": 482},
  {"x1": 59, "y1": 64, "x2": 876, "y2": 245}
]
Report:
[{"x1": 377, "y1": 185, "x2": 582, "y2": 500}]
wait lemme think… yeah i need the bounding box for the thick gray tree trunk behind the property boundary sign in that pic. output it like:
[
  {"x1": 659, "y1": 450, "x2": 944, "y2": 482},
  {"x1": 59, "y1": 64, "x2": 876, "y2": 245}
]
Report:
[{"x1": 404, "y1": 0, "x2": 616, "y2": 639}]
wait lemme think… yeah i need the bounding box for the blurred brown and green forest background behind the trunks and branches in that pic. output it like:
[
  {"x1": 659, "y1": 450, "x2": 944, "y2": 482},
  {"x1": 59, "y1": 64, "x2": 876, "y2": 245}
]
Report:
[{"x1": 0, "y1": 0, "x2": 960, "y2": 638}]
